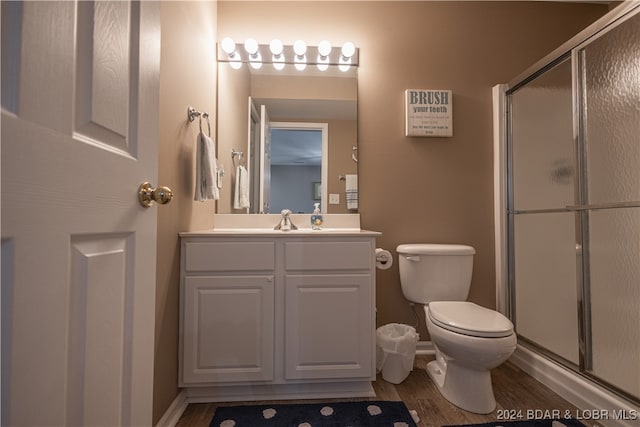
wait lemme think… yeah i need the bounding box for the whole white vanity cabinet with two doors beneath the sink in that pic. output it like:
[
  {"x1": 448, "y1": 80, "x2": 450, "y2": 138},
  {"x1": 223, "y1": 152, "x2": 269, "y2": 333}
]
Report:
[{"x1": 180, "y1": 231, "x2": 378, "y2": 401}]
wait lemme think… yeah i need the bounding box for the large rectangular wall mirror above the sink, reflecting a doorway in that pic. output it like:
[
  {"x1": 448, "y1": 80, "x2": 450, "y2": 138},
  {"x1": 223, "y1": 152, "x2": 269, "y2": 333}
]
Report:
[{"x1": 217, "y1": 62, "x2": 358, "y2": 213}]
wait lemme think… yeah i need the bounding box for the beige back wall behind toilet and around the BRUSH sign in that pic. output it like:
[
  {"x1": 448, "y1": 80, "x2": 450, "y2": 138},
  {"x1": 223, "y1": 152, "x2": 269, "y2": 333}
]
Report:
[{"x1": 218, "y1": 1, "x2": 608, "y2": 339}]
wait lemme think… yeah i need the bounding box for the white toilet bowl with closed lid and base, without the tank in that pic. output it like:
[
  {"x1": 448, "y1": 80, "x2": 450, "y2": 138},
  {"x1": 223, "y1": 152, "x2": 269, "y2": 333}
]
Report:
[{"x1": 425, "y1": 301, "x2": 516, "y2": 414}]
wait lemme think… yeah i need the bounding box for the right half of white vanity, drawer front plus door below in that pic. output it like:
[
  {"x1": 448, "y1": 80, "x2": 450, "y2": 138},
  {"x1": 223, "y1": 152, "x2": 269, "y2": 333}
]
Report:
[{"x1": 284, "y1": 239, "x2": 375, "y2": 379}]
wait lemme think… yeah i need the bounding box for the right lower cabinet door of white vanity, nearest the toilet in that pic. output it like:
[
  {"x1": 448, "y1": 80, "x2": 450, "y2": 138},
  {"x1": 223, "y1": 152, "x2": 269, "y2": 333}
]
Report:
[{"x1": 285, "y1": 274, "x2": 375, "y2": 380}]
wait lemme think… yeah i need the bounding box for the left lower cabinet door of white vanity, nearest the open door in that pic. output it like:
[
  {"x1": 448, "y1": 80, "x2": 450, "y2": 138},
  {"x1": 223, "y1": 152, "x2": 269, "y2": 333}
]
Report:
[{"x1": 182, "y1": 276, "x2": 274, "y2": 385}]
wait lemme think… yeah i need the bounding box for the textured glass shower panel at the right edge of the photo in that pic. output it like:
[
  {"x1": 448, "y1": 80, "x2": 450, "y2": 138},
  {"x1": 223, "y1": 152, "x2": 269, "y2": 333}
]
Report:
[{"x1": 576, "y1": 14, "x2": 640, "y2": 400}]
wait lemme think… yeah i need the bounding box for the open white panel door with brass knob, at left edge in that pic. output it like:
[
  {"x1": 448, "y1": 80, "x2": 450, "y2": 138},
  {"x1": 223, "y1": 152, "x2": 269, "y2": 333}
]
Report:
[{"x1": 2, "y1": 1, "x2": 160, "y2": 426}]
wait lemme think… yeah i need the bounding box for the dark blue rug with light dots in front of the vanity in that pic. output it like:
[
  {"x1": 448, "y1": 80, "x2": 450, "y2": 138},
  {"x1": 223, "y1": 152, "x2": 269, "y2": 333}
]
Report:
[{"x1": 209, "y1": 401, "x2": 417, "y2": 427}]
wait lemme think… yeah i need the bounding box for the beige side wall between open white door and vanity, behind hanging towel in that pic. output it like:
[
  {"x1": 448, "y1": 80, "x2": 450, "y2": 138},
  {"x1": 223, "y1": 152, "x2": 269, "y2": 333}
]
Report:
[{"x1": 153, "y1": 1, "x2": 217, "y2": 424}]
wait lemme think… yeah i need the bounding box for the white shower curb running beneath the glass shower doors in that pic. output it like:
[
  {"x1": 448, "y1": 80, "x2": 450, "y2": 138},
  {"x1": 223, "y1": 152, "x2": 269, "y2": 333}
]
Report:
[{"x1": 509, "y1": 345, "x2": 640, "y2": 427}]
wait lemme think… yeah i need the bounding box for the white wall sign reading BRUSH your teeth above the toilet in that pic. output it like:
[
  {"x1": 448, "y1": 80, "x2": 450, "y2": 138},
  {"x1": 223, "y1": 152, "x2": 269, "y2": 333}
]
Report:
[{"x1": 404, "y1": 89, "x2": 453, "y2": 136}]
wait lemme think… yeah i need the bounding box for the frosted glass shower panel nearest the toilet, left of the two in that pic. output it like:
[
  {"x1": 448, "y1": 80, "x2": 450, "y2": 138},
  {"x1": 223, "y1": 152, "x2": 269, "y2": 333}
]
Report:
[{"x1": 508, "y1": 55, "x2": 579, "y2": 366}]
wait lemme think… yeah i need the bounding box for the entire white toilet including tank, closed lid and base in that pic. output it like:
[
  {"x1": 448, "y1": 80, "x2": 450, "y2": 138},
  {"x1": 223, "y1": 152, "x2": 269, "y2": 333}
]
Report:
[{"x1": 396, "y1": 243, "x2": 516, "y2": 414}]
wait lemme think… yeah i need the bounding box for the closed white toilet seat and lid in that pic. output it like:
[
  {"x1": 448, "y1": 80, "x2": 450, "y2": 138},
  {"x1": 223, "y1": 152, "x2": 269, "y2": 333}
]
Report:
[{"x1": 429, "y1": 301, "x2": 513, "y2": 338}]
